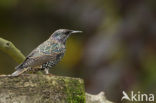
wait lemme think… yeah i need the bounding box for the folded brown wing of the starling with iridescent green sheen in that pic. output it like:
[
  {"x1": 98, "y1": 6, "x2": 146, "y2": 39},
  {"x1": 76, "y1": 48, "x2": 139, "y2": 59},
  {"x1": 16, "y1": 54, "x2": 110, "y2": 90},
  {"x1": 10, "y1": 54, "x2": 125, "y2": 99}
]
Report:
[{"x1": 15, "y1": 41, "x2": 62, "y2": 69}]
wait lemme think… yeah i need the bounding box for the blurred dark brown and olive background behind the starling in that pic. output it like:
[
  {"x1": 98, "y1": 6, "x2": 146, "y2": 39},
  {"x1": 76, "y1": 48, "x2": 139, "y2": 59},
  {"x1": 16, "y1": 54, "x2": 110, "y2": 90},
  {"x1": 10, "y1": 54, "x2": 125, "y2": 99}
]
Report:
[{"x1": 0, "y1": 0, "x2": 156, "y2": 102}]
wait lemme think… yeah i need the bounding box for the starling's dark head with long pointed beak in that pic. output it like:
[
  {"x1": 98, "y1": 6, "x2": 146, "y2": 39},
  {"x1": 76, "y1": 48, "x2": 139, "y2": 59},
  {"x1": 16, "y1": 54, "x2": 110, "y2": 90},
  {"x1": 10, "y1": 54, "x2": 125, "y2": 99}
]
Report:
[{"x1": 50, "y1": 29, "x2": 82, "y2": 43}]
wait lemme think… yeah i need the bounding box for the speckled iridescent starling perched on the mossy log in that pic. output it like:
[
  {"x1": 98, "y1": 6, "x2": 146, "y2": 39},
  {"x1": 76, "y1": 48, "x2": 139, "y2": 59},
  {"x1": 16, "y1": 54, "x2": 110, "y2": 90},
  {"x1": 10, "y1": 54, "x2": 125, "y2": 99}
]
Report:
[{"x1": 12, "y1": 29, "x2": 82, "y2": 76}]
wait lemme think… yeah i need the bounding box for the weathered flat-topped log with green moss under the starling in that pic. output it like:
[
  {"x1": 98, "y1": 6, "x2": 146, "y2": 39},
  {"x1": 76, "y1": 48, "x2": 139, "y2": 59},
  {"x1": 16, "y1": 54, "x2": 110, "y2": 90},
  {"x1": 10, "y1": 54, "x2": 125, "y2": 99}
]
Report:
[{"x1": 0, "y1": 74, "x2": 85, "y2": 103}]
